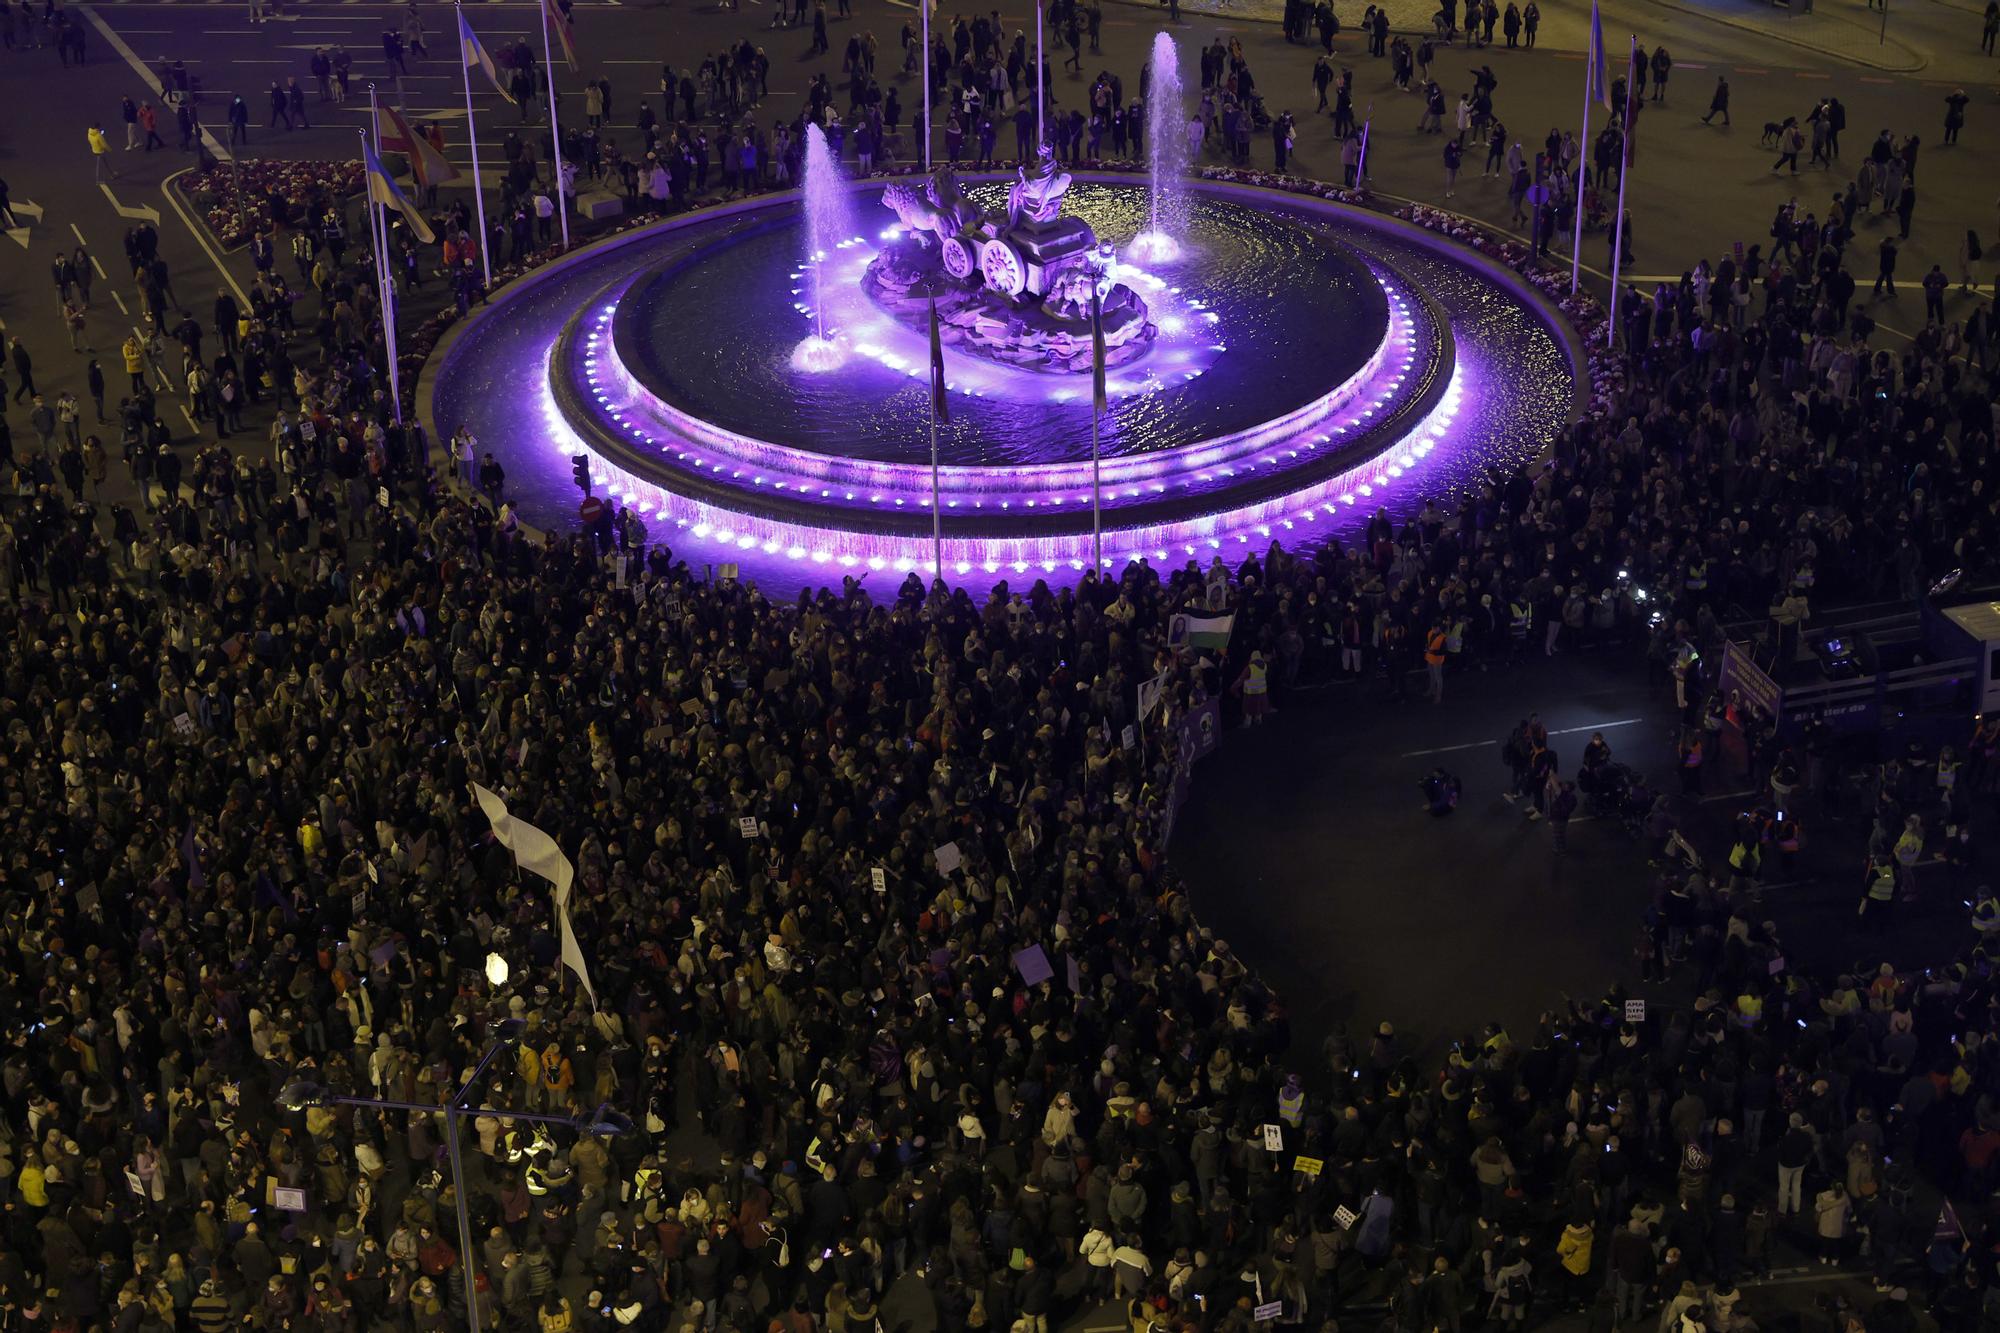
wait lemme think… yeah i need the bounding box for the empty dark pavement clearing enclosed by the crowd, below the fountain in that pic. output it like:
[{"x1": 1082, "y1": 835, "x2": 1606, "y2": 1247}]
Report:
[{"x1": 1172, "y1": 652, "x2": 1978, "y2": 1061}]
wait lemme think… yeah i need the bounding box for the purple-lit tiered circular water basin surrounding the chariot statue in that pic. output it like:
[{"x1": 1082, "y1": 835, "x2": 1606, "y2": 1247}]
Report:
[{"x1": 430, "y1": 178, "x2": 1578, "y2": 586}]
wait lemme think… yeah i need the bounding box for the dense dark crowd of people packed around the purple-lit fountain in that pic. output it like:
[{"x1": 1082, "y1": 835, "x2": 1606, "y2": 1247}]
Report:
[{"x1": 11, "y1": 6, "x2": 2000, "y2": 1333}]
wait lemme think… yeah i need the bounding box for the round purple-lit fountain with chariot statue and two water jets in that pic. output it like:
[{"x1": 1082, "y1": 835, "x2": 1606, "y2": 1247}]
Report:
[{"x1": 420, "y1": 29, "x2": 1578, "y2": 584}]
